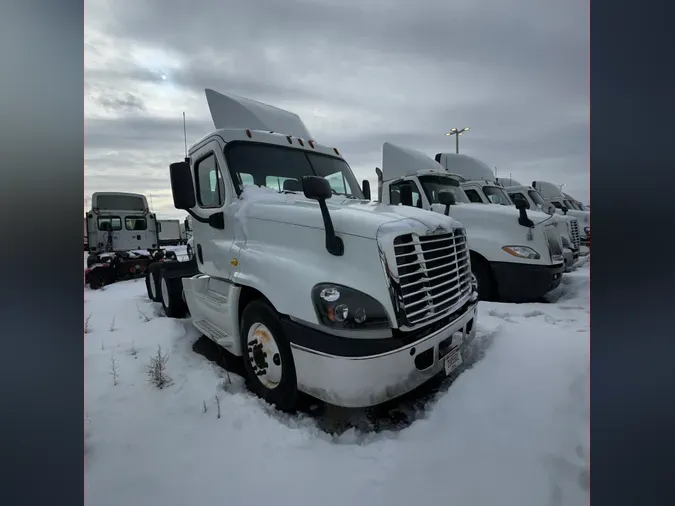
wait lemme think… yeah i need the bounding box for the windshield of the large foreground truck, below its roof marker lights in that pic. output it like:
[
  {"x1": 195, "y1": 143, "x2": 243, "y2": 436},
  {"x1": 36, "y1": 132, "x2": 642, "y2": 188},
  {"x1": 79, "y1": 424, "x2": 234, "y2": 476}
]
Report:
[{"x1": 225, "y1": 142, "x2": 364, "y2": 199}]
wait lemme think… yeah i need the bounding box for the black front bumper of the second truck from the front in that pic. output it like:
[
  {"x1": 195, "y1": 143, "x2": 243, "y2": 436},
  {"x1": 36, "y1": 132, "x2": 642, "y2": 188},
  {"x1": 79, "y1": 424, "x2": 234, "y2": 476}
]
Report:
[{"x1": 490, "y1": 262, "x2": 565, "y2": 302}]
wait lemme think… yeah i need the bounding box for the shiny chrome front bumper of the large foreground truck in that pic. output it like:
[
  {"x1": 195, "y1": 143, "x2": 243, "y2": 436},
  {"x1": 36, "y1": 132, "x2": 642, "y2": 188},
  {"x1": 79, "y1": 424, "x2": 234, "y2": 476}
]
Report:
[{"x1": 282, "y1": 302, "x2": 477, "y2": 408}]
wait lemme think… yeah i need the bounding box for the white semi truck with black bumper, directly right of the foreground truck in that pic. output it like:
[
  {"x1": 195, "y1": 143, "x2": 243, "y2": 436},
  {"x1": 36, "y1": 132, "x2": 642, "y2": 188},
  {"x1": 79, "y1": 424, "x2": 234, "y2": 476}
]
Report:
[{"x1": 376, "y1": 143, "x2": 564, "y2": 302}]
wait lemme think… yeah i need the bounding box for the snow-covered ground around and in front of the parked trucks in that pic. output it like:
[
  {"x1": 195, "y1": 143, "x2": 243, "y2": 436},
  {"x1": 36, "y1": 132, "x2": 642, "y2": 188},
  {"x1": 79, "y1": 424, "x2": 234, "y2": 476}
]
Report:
[{"x1": 84, "y1": 247, "x2": 590, "y2": 506}]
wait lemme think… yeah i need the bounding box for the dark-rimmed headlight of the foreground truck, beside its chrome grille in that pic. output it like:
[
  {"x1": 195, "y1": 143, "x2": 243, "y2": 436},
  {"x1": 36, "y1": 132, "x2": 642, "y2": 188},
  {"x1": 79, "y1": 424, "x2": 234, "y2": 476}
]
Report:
[{"x1": 312, "y1": 283, "x2": 391, "y2": 330}]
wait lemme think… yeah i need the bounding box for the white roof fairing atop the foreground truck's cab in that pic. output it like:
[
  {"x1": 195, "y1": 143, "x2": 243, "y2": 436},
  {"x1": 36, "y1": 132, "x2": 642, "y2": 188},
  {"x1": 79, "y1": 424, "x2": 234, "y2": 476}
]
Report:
[{"x1": 205, "y1": 88, "x2": 314, "y2": 139}]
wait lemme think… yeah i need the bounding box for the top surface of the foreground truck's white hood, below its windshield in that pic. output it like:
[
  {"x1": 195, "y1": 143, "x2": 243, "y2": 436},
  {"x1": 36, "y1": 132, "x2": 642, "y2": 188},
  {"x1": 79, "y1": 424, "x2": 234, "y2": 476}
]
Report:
[{"x1": 235, "y1": 189, "x2": 459, "y2": 239}]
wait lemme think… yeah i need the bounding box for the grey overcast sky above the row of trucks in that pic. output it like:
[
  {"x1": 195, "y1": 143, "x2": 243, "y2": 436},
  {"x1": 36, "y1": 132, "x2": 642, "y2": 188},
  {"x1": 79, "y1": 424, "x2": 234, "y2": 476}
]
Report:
[{"x1": 84, "y1": 0, "x2": 590, "y2": 218}]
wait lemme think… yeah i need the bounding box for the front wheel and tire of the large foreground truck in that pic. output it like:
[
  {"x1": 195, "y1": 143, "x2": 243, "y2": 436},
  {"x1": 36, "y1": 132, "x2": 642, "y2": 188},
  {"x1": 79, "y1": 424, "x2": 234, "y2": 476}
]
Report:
[{"x1": 239, "y1": 300, "x2": 298, "y2": 412}]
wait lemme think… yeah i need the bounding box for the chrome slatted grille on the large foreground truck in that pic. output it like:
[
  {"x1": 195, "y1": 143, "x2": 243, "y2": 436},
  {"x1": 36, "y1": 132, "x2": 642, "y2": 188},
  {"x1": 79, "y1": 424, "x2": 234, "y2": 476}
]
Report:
[{"x1": 394, "y1": 229, "x2": 471, "y2": 326}]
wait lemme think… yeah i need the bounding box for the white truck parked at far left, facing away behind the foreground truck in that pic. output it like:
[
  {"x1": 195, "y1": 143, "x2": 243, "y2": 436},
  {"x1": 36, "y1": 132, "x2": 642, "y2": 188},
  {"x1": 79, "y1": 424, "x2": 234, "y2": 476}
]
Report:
[{"x1": 84, "y1": 192, "x2": 175, "y2": 289}]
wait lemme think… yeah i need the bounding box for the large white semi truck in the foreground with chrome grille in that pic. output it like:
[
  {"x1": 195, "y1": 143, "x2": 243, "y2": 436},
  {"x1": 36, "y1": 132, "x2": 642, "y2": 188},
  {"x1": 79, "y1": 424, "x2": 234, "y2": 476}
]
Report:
[{"x1": 150, "y1": 89, "x2": 477, "y2": 410}]
